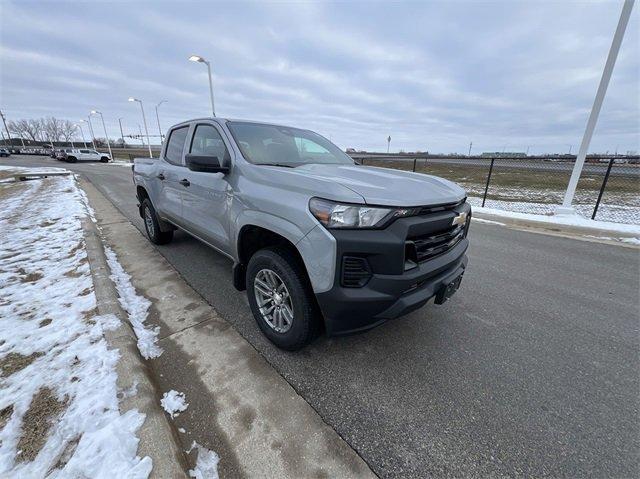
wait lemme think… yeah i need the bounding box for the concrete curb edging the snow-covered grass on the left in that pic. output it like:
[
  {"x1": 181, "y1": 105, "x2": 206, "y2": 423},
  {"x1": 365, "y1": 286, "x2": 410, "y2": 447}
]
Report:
[{"x1": 82, "y1": 218, "x2": 187, "y2": 478}]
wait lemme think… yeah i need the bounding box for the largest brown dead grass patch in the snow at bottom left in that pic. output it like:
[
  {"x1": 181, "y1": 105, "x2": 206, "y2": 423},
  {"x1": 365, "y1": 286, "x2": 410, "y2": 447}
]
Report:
[{"x1": 18, "y1": 387, "x2": 67, "y2": 462}]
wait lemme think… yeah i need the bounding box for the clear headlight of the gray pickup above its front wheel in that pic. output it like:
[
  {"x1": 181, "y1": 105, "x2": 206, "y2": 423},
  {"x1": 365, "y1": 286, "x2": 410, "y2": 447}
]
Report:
[{"x1": 309, "y1": 198, "x2": 409, "y2": 228}]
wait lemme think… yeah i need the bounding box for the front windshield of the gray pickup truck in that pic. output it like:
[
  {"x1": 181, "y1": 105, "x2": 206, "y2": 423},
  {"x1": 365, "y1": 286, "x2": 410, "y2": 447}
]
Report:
[{"x1": 227, "y1": 121, "x2": 354, "y2": 167}]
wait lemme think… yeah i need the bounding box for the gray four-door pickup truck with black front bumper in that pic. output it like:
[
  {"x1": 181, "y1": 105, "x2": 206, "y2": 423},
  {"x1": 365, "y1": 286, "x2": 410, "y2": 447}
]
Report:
[{"x1": 133, "y1": 118, "x2": 471, "y2": 350}]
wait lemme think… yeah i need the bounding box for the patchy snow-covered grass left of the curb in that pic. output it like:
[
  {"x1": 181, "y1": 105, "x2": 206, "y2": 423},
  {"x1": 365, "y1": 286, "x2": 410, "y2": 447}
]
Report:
[{"x1": 0, "y1": 168, "x2": 152, "y2": 478}]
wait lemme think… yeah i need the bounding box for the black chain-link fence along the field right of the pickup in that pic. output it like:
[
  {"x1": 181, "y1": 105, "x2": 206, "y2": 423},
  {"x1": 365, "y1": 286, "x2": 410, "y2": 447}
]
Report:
[{"x1": 352, "y1": 154, "x2": 640, "y2": 224}]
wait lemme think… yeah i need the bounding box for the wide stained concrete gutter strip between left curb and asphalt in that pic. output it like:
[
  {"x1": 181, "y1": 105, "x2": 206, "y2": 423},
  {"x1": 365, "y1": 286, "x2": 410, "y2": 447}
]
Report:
[{"x1": 81, "y1": 181, "x2": 375, "y2": 478}]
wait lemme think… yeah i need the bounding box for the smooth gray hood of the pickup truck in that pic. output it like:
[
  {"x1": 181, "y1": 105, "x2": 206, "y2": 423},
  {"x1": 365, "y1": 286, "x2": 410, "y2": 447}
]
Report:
[{"x1": 291, "y1": 164, "x2": 466, "y2": 206}]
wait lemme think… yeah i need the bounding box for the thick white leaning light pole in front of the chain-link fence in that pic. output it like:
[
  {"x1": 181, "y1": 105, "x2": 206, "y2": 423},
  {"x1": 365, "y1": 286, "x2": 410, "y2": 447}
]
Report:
[{"x1": 556, "y1": 0, "x2": 635, "y2": 214}]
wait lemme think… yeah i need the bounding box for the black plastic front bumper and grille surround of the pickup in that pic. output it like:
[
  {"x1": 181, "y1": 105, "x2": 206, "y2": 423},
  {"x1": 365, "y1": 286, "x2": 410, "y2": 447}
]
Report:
[{"x1": 316, "y1": 204, "x2": 470, "y2": 335}]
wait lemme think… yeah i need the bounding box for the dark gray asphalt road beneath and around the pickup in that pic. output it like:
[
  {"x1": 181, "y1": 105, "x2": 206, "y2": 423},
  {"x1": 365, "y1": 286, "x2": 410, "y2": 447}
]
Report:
[{"x1": 1, "y1": 157, "x2": 640, "y2": 477}]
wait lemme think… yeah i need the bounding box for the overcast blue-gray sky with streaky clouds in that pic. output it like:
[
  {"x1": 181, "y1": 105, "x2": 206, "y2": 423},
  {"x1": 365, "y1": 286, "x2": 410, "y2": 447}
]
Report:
[{"x1": 0, "y1": 0, "x2": 640, "y2": 153}]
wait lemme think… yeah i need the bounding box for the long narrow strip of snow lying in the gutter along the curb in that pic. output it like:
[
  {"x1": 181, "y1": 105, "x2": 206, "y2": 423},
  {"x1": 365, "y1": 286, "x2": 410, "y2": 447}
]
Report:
[{"x1": 104, "y1": 245, "x2": 162, "y2": 359}]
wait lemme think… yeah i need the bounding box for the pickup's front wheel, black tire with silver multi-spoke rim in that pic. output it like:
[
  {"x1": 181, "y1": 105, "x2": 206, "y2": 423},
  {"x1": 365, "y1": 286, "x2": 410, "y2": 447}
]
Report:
[{"x1": 246, "y1": 247, "x2": 321, "y2": 351}]
